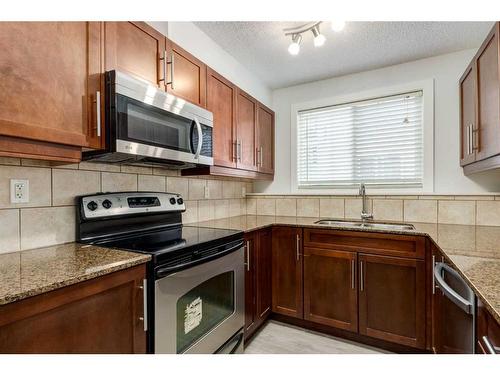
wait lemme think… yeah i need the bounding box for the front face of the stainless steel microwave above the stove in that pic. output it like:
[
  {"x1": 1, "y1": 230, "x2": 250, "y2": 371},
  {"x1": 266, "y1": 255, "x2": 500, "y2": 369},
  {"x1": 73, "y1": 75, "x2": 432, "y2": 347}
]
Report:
[{"x1": 114, "y1": 94, "x2": 213, "y2": 165}]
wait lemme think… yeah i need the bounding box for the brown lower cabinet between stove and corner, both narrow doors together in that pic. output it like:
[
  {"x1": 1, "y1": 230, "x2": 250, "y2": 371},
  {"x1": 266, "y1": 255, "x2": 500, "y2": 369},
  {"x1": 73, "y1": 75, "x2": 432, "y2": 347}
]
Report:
[{"x1": 245, "y1": 228, "x2": 271, "y2": 338}]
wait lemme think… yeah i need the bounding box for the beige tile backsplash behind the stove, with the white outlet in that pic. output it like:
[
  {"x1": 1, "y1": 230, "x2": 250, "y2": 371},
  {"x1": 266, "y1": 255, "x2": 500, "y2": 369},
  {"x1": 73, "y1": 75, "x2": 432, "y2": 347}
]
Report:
[{"x1": 0, "y1": 157, "x2": 252, "y2": 253}]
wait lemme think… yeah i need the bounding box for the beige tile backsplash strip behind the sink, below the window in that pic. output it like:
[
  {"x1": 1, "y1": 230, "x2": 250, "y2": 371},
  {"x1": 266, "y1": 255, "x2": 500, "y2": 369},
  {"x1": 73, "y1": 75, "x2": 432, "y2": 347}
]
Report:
[{"x1": 246, "y1": 194, "x2": 500, "y2": 226}]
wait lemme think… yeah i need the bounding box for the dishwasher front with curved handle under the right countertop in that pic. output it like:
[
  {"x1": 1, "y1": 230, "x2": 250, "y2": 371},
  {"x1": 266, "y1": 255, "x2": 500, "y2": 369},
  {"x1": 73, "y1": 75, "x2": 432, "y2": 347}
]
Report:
[{"x1": 433, "y1": 262, "x2": 476, "y2": 354}]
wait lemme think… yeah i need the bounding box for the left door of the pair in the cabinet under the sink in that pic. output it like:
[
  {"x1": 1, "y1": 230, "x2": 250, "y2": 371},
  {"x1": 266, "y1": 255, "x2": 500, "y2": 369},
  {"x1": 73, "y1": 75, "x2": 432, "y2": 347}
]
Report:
[{"x1": 304, "y1": 247, "x2": 358, "y2": 332}]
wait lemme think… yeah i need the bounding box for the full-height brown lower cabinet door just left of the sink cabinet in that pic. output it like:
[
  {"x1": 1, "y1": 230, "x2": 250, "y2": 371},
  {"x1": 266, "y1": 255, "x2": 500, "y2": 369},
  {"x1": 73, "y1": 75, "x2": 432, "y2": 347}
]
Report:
[{"x1": 272, "y1": 227, "x2": 303, "y2": 318}]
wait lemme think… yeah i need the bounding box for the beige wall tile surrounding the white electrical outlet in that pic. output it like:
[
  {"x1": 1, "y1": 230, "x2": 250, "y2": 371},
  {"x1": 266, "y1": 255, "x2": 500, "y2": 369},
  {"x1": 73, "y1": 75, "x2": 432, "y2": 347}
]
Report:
[{"x1": 0, "y1": 166, "x2": 52, "y2": 208}]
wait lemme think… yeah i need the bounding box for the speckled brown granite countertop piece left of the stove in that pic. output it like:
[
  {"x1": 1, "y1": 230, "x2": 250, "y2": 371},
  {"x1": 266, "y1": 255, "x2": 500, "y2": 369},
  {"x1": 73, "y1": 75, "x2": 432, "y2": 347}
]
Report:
[{"x1": 0, "y1": 243, "x2": 151, "y2": 305}]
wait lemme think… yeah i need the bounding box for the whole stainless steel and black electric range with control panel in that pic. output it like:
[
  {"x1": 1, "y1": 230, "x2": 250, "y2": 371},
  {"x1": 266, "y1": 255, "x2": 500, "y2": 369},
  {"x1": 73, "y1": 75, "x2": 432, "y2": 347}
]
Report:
[{"x1": 77, "y1": 192, "x2": 244, "y2": 353}]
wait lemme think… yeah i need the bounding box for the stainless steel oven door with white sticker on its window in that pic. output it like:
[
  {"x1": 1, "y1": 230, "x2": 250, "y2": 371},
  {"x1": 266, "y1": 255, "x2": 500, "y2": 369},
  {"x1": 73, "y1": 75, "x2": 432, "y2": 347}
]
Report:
[{"x1": 154, "y1": 247, "x2": 244, "y2": 354}]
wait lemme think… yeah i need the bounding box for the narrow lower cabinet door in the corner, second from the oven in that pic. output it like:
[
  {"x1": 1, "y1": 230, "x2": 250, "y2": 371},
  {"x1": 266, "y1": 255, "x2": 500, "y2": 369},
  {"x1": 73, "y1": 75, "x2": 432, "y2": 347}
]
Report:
[{"x1": 256, "y1": 229, "x2": 272, "y2": 323}]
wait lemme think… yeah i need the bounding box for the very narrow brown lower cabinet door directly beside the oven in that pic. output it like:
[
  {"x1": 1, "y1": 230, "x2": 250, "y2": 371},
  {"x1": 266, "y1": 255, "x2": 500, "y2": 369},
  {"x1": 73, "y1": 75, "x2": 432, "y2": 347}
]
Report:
[{"x1": 245, "y1": 233, "x2": 256, "y2": 336}]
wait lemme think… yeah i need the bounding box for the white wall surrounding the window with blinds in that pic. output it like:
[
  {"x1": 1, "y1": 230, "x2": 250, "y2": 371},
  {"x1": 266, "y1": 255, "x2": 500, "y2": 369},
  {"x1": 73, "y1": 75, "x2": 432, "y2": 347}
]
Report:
[{"x1": 255, "y1": 50, "x2": 500, "y2": 194}]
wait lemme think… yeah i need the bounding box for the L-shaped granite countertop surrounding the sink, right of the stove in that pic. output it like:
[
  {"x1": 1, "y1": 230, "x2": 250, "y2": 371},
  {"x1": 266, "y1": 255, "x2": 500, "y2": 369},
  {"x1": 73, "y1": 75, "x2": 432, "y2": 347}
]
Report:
[{"x1": 194, "y1": 215, "x2": 500, "y2": 324}]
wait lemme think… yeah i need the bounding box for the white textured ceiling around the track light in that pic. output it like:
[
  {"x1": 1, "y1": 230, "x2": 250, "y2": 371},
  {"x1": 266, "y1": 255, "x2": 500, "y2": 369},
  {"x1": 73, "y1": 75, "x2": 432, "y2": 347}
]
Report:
[{"x1": 195, "y1": 22, "x2": 493, "y2": 89}]
